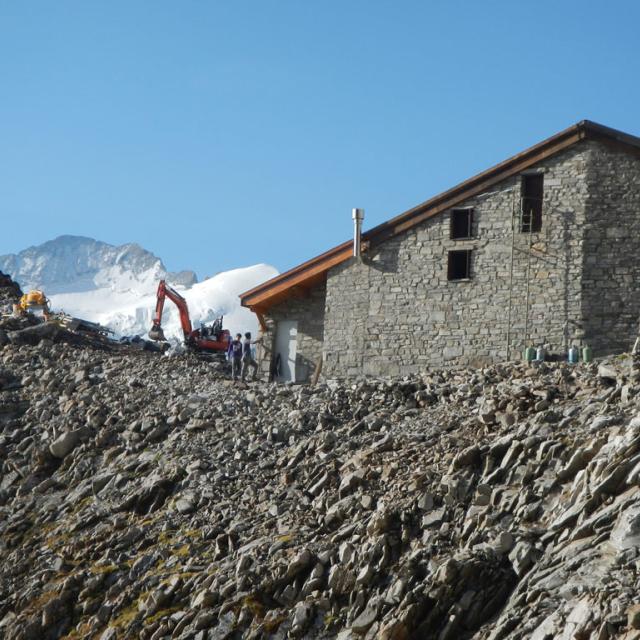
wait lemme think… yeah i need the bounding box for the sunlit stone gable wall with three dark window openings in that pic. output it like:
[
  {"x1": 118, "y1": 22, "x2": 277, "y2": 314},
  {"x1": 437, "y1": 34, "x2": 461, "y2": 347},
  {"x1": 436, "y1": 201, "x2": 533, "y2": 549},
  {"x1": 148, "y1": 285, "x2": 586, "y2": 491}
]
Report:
[{"x1": 323, "y1": 142, "x2": 593, "y2": 377}]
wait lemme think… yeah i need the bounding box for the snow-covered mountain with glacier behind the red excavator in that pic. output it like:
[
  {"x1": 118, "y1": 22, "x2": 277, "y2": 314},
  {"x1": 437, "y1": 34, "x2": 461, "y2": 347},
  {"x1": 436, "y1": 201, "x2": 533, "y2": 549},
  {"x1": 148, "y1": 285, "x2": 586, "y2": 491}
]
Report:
[{"x1": 0, "y1": 236, "x2": 278, "y2": 340}]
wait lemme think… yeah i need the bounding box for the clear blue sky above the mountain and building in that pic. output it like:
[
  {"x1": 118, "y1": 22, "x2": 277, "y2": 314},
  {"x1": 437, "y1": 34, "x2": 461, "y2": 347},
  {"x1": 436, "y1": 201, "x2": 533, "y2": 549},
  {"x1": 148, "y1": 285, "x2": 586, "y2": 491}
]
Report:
[{"x1": 0, "y1": 0, "x2": 640, "y2": 277}]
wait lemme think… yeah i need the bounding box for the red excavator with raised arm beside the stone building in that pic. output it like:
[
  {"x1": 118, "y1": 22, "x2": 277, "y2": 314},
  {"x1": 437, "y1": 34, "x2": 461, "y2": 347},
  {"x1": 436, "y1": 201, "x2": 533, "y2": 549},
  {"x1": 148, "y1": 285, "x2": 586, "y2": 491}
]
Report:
[{"x1": 149, "y1": 280, "x2": 231, "y2": 353}]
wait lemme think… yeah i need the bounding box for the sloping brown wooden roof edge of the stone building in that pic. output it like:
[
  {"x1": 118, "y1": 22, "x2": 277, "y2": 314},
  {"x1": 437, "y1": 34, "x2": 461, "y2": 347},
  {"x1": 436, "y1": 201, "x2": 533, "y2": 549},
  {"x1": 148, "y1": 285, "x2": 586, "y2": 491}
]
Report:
[{"x1": 240, "y1": 120, "x2": 640, "y2": 313}]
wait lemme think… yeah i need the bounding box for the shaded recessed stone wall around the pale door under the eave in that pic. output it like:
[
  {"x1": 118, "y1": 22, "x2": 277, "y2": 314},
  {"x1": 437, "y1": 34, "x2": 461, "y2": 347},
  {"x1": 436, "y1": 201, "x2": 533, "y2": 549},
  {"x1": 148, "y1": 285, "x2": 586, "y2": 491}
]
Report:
[{"x1": 257, "y1": 284, "x2": 326, "y2": 382}]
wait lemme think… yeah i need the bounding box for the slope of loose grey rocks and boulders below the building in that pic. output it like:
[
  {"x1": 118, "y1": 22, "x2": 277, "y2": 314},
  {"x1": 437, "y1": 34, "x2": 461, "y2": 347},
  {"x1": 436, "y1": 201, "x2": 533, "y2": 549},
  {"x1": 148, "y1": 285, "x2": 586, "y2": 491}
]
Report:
[{"x1": 0, "y1": 294, "x2": 640, "y2": 640}]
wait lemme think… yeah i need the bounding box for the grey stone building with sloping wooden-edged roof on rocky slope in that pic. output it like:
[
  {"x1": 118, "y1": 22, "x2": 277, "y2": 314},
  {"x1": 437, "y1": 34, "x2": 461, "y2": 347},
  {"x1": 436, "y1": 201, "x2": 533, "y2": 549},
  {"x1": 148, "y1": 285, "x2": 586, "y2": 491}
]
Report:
[{"x1": 241, "y1": 121, "x2": 640, "y2": 382}]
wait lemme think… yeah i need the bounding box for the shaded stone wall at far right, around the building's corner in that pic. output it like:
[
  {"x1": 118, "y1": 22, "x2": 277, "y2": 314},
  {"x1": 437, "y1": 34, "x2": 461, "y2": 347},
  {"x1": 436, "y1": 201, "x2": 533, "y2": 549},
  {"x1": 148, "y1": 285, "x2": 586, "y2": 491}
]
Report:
[{"x1": 582, "y1": 143, "x2": 640, "y2": 355}]
